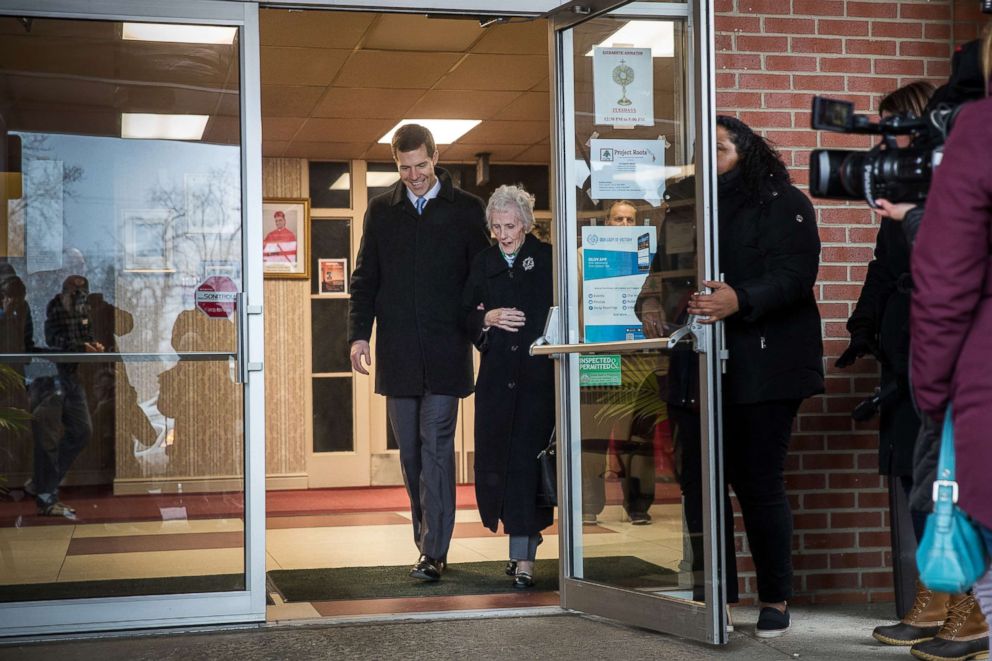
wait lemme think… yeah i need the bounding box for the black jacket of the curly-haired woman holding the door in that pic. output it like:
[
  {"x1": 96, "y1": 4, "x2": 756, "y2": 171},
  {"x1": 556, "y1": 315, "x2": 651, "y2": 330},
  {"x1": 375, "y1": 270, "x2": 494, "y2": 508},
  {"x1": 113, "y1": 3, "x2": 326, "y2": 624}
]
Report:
[{"x1": 719, "y1": 169, "x2": 823, "y2": 404}]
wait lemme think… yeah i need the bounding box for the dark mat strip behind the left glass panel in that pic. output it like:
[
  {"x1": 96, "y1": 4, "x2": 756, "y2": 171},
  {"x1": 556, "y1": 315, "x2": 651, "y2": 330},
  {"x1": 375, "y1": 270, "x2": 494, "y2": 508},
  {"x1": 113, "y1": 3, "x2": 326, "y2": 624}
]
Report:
[{"x1": 0, "y1": 574, "x2": 245, "y2": 602}]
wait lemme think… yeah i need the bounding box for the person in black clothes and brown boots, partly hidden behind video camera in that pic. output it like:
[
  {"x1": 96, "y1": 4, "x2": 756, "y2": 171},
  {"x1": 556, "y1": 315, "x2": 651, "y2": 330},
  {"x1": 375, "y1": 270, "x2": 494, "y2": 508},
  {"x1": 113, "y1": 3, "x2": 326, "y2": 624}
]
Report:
[{"x1": 835, "y1": 81, "x2": 945, "y2": 645}]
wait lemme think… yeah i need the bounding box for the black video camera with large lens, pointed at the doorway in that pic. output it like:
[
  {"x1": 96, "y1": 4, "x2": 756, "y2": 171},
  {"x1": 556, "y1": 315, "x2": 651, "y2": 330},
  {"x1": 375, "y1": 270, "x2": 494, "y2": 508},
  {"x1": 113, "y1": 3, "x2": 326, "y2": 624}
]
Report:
[{"x1": 809, "y1": 96, "x2": 963, "y2": 207}]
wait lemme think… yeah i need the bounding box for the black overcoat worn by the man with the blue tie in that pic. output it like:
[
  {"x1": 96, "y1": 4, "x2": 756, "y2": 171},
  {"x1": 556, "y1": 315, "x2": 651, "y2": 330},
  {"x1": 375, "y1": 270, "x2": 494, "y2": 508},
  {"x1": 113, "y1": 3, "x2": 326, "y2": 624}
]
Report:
[{"x1": 348, "y1": 168, "x2": 489, "y2": 397}]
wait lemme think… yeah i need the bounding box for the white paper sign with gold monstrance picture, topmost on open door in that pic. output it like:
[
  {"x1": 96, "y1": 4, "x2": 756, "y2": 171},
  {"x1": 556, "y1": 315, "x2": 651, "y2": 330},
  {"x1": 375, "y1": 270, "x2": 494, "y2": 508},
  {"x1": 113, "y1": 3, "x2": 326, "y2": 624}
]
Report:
[{"x1": 592, "y1": 46, "x2": 654, "y2": 127}]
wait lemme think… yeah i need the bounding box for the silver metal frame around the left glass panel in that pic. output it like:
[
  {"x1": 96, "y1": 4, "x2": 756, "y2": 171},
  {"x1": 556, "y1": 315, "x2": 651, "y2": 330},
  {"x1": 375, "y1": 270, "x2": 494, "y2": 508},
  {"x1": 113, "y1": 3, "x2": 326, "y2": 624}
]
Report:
[{"x1": 0, "y1": 0, "x2": 265, "y2": 636}]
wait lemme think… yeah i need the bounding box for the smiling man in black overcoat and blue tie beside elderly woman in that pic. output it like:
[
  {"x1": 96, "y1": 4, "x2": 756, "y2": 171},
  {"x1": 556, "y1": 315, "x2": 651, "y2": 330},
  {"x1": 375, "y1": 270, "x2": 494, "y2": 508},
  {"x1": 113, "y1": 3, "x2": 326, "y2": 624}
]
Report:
[{"x1": 348, "y1": 124, "x2": 488, "y2": 581}]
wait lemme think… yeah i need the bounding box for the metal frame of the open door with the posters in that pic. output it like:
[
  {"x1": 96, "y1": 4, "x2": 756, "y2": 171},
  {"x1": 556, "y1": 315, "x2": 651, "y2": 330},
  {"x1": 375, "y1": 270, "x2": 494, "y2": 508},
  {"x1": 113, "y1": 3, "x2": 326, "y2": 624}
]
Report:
[{"x1": 549, "y1": 0, "x2": 734, "y2": 644}]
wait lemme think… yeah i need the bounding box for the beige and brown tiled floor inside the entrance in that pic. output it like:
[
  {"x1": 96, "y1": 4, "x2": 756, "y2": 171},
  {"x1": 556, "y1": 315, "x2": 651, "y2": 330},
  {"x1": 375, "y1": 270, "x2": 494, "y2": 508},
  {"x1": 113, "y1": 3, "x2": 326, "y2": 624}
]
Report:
[{"x1": 0, "y1": 484, "x2": 696, "y2": 621}]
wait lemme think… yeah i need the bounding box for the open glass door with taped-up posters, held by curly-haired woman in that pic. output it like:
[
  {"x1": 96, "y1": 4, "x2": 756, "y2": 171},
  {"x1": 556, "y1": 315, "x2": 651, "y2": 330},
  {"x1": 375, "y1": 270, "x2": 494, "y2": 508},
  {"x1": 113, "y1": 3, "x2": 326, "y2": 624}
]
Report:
[{"x1": 544, "y1": 2, "x2": 733, "y2": 643}]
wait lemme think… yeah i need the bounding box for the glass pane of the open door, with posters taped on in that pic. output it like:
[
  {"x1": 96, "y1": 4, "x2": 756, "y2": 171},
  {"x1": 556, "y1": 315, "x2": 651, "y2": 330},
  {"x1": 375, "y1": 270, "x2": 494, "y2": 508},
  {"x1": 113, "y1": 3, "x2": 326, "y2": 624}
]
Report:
[{"x1": 571, "y1": 17, "x2": 704, "y2": 601}]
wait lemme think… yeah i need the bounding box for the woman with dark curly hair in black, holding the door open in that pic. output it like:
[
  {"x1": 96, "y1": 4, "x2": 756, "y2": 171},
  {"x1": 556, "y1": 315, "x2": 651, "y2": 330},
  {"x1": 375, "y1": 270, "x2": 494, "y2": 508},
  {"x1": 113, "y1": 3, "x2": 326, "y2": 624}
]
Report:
[{"x1": 687, "y1": 116, "x2": 824, "y2": 638}]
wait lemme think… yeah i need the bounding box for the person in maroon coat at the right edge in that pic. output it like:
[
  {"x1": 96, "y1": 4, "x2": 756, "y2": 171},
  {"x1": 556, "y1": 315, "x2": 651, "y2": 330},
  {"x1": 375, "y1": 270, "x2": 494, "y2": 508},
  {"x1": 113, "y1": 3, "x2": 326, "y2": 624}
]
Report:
[{"x1": 911, "y1": 26, "x2": 992, "y2": 658}]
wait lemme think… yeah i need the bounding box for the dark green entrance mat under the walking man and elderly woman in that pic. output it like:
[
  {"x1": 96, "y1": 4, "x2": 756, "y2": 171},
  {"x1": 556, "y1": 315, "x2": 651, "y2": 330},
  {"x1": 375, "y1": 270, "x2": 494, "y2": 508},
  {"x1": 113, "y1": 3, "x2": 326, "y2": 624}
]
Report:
[{"x1": 268, "y1": 556, "x2": 678, "y2": 602}]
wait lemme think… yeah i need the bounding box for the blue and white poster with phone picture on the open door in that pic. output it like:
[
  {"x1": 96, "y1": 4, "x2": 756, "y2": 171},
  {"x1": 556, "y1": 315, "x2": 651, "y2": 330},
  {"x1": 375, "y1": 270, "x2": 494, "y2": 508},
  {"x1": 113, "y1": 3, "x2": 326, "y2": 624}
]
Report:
[{"x1": 582, "y1": 226, "x2": 658, "y2": 342}]
